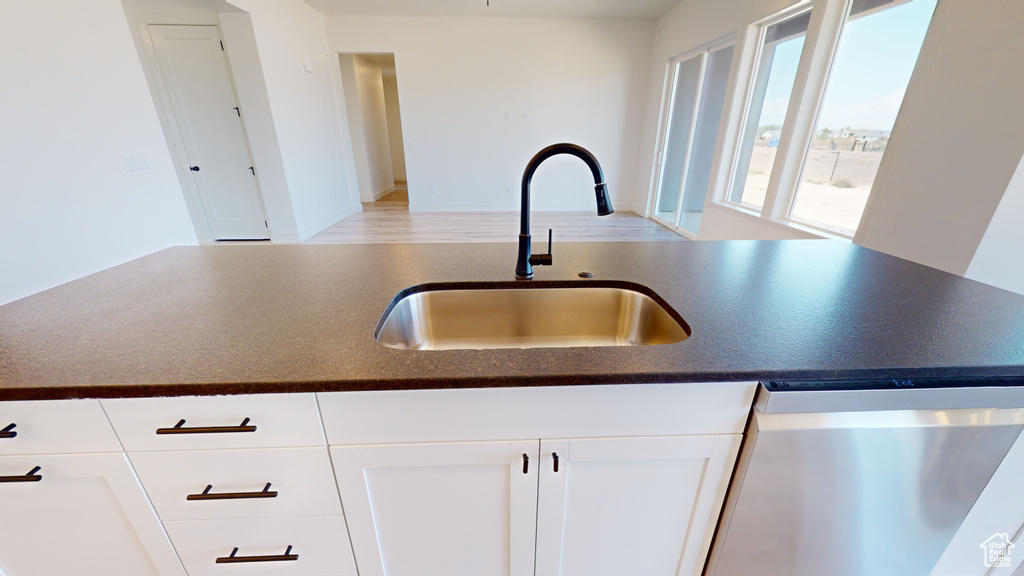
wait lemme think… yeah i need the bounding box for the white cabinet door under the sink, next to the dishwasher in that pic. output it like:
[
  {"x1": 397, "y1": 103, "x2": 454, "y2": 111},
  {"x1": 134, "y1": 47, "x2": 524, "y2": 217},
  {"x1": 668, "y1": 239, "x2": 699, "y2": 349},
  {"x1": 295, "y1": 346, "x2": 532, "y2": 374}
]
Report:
[{"x1": 537, "y1": 435, "x2": 740, "y2": 576}]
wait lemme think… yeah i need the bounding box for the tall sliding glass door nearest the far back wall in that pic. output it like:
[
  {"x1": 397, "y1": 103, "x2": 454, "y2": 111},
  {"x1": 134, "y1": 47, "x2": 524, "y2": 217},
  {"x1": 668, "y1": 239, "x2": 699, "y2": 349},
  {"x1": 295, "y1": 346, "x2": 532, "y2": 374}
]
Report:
[{"x1": 653, "y1": 40, "x2": 733, "y2": 234}]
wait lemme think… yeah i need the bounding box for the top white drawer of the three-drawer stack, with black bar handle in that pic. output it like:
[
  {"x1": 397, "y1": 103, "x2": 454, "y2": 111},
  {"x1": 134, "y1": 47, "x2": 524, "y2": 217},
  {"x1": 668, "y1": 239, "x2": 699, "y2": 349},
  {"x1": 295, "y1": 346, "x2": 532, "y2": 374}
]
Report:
[{"x1": 100, "y1": 394, "x2": 325, "y2": 452}]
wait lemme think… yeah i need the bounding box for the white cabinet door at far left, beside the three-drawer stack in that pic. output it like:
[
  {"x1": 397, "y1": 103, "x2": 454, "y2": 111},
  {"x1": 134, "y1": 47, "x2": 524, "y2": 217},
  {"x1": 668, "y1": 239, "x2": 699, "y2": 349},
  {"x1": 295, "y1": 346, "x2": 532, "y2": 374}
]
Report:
[{"x1": 0, "y1": 454, "x2": 185, "y2": 576}]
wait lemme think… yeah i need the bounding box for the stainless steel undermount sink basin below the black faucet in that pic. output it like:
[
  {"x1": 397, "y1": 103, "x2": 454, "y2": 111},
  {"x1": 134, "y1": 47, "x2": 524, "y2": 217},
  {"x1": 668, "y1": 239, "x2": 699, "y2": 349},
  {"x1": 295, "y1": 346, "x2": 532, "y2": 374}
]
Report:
[{"x1": 375, "y1": 281, "x2": 690, "y2": 349}]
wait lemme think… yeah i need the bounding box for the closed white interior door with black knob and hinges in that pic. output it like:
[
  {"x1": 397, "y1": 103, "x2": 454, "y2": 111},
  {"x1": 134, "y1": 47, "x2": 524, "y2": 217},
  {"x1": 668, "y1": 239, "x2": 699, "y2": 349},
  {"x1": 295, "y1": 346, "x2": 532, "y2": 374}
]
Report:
[{"x1": 150, "y1": 26, "x2": 270, "y2": 240}]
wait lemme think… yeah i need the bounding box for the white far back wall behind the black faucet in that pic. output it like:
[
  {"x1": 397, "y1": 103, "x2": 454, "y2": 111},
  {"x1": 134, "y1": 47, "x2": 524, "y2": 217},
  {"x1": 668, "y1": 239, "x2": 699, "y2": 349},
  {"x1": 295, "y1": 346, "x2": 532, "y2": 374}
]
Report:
[{"x1": 327, "y1": 16, "x2": 652, "y2": 211}]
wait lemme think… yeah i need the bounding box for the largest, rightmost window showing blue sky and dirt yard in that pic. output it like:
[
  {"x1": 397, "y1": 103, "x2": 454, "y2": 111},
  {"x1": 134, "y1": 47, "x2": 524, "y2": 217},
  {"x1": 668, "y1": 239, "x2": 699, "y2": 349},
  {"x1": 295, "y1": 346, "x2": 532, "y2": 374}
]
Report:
[{"x1": 790, "y1": 0, "x2": 936, "y2": 236}]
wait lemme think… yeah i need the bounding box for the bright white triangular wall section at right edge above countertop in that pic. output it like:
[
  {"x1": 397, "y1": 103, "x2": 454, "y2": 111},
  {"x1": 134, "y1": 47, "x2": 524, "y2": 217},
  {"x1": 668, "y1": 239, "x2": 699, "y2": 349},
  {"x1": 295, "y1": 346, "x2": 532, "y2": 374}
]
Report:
[{"x1": 967, "y1": 151, "x2": 1024, "y2": 294}]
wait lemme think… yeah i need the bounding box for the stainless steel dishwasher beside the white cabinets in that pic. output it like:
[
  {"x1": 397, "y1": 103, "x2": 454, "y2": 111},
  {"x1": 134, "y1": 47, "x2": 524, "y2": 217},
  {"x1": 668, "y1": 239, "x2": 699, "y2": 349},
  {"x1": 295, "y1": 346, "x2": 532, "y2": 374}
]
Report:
[{"x1": 705, "y1": 378, "x2": 1024, "y2": 576}]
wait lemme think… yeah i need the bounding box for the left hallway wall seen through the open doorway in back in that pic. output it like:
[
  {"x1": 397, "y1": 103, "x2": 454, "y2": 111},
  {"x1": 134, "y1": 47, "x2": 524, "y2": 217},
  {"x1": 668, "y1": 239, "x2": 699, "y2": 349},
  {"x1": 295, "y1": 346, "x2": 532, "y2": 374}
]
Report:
[{"x1": 352, "y1": 55, "x2": 394, "y2": 196}]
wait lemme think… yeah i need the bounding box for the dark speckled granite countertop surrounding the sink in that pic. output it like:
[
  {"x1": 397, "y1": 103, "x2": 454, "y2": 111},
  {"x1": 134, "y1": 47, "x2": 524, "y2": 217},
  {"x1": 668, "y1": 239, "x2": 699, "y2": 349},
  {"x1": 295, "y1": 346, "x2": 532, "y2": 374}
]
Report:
[{"x1": 0, "y1": 240, "x2": 1024, "y2": 400}]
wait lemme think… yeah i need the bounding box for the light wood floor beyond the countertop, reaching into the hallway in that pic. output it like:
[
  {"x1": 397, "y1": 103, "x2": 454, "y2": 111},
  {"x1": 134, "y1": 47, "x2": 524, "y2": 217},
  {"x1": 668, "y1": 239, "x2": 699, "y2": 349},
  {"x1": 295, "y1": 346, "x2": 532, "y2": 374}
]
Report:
[{"x1": 306, "y1": 182, "x2": 685, "y2": 244}]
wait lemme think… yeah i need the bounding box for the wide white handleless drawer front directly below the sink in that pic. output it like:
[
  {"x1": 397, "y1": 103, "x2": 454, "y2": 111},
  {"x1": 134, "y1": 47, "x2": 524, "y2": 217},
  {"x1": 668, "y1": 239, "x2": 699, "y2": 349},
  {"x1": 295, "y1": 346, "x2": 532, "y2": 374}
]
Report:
[{"x1": 317, "y1": 382, "x2": 757, "y2": 445}]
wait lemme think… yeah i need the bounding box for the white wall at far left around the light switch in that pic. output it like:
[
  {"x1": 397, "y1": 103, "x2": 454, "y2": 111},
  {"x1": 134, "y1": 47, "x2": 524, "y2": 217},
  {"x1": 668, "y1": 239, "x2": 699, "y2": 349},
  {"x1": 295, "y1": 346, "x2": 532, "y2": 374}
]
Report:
[{"x1": 0, "y1": 0, "x2": 197, "y2": 303}]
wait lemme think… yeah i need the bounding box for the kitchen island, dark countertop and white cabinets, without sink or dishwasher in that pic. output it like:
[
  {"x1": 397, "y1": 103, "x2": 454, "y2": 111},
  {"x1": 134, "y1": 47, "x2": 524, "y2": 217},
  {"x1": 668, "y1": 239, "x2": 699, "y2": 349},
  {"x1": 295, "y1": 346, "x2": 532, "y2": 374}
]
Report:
[{"x1": 0, "y1": 241, "x2": 1024, "y2": 576}]
